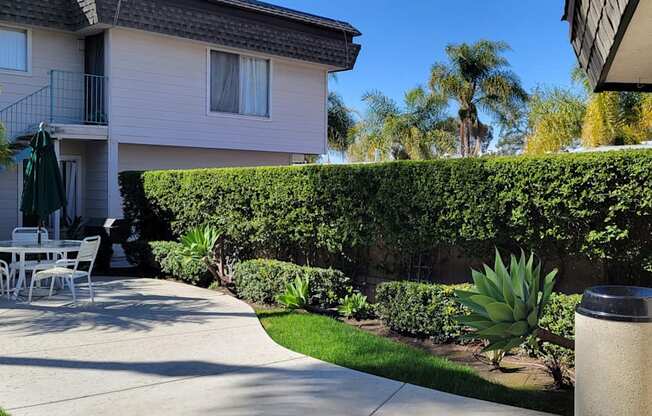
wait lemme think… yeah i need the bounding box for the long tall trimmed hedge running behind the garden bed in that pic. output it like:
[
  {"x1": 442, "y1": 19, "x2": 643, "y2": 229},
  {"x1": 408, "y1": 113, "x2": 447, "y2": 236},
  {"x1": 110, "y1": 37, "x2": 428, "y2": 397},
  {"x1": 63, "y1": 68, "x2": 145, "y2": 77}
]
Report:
[{"x1": 120, "y1": 150, "x2": 652, "y2": 282}]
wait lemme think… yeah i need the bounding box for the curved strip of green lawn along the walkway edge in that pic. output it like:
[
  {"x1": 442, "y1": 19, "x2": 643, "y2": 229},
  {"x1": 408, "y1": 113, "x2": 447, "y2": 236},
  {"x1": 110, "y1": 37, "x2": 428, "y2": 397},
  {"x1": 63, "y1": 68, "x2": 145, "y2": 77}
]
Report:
[{"x1": 256, "y1": 310, "x2": 573, "y2": 415}]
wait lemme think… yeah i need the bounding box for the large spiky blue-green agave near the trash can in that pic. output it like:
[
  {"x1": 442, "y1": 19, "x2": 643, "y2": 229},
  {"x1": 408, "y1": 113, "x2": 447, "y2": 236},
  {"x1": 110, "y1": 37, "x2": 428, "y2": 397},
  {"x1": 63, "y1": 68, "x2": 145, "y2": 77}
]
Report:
[{"x1": 455, "y1": 250, "x2": 557, "y2": 351}]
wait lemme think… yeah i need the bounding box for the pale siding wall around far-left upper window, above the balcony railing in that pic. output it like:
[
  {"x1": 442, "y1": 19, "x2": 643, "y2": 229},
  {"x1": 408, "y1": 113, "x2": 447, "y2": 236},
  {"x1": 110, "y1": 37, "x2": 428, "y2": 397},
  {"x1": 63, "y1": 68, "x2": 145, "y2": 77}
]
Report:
[{"x1": 0, "y1": 21, "x2": 84, "y2": 110}]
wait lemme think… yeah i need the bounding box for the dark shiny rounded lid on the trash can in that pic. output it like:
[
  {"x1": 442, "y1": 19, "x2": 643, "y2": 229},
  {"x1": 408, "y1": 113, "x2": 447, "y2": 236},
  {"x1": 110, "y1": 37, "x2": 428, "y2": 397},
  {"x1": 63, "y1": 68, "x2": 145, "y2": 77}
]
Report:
[{"x1": 577, "y1": 286, "x2": 652, "y2": 322}]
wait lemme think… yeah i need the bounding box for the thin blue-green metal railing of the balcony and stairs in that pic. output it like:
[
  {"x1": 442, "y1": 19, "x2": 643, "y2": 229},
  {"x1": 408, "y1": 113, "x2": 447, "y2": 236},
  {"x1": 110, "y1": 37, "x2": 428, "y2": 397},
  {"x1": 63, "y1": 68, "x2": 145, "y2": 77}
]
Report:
[{"x1": 0, "y1": 71, "x2": 108, "y2": 141}]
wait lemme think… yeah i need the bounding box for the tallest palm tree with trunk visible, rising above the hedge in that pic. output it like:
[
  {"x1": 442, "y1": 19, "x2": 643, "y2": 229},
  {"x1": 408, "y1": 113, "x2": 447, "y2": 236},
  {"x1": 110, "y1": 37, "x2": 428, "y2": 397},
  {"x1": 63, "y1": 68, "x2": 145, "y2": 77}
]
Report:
[{"x1": 430, "y1": 40, "x2": 527, "y2": 156}]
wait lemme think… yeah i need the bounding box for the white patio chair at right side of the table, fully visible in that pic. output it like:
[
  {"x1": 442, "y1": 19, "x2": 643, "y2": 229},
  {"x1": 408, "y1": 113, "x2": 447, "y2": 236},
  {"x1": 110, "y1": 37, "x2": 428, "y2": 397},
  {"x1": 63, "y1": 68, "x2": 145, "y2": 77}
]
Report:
[{"x1": 27, "y1": 236, "x2": 101, "y2": 303}]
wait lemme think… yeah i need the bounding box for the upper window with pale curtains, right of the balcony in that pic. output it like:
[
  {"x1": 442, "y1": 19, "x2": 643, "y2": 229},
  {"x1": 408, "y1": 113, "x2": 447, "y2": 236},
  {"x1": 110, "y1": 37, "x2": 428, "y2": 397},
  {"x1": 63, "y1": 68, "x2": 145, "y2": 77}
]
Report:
[{"x1": 209, "y1": 51, "x2": 270, "y2": 117}]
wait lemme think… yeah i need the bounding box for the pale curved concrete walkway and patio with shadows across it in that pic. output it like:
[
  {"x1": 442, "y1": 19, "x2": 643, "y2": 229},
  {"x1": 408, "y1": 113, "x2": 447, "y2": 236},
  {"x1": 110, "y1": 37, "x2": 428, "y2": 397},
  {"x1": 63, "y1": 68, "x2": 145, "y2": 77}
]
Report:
[{"x1": 0, "y1": 279, "x2": 552, "y2": 416}]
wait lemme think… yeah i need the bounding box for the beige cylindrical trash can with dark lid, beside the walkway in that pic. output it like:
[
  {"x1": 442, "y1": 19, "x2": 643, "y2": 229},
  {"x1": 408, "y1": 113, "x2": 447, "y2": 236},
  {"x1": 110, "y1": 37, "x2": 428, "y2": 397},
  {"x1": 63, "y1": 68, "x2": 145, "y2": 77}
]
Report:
[{"x1": 575, "y1": 286, "x2": 652, "y2": 416}]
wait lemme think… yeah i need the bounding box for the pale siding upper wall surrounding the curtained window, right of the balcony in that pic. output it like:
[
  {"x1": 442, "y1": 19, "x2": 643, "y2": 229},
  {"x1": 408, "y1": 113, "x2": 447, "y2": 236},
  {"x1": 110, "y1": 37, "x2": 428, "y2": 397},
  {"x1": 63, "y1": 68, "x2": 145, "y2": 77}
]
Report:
[{"x1": 108, "y1": 29, "x2": 327, "y2": 154}]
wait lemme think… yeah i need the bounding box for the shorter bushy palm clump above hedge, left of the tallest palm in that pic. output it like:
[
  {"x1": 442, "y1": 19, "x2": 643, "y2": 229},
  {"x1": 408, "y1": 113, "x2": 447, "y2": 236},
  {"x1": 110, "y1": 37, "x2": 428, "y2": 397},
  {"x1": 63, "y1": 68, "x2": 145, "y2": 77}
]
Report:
[{"x1": 349, "y1": 87, "x2": 457, "y2": 161}]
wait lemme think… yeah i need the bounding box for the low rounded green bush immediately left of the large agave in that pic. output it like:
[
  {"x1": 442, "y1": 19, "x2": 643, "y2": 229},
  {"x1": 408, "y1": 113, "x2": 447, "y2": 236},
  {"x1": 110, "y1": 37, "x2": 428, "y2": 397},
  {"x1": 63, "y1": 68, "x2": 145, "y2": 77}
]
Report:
[{"x1": 376, "y1": 281, "x2": 470, "y2": 342}]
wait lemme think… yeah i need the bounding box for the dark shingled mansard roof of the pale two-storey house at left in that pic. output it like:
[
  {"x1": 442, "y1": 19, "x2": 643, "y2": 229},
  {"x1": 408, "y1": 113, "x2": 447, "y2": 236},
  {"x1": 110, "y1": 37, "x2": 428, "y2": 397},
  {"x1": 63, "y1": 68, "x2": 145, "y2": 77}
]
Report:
[{"x1": 0, "y1": 0, "x2": 360, "y2": 69}]
